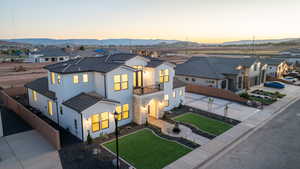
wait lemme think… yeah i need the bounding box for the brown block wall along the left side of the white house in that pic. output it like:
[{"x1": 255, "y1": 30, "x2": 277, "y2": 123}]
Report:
[{"x1": 0, "y1": 88, "x2": 60, "y2": 150}]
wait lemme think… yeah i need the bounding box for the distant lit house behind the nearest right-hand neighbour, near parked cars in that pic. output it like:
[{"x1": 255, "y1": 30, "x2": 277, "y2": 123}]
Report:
[{"x1": 260, "y1": 58, "x2": 289, "y2": 78}]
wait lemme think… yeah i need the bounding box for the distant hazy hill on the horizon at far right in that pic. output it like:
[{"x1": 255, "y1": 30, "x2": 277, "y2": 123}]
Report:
[{"x1": 222, "y1": 38, "x2": 300, "y2": 46}]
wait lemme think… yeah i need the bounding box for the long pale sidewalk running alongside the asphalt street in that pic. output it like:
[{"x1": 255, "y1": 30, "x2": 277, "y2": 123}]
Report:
[{"x1": 164, "y1": 85, "x2": 300, "y2": 169}]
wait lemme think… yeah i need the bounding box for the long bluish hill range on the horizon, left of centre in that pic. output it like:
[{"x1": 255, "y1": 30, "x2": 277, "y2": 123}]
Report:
[{"x1": 5, "y1": 38, "x2": 186, "y2": 45}]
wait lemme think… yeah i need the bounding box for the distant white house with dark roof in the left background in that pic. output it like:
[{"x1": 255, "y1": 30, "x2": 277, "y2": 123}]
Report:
[{"x1": 25, "y1": 47, "x2": 70, "y2": 63}]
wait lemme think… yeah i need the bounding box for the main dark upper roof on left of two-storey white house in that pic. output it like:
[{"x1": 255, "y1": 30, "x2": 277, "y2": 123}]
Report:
[{"x1": 44, "y1": 54, "x2": 137, "y2": 74}]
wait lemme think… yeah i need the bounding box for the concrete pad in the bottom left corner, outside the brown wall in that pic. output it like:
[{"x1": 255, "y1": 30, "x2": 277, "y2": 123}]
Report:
[{"x1": 0, "y1": 130, "x2": 62, "y2": 169}]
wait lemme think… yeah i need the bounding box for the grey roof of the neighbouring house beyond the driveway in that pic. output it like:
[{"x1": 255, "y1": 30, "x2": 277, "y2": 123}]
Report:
[{"x1": 176, "y1": 57, "x2": 257, "y2": 79}]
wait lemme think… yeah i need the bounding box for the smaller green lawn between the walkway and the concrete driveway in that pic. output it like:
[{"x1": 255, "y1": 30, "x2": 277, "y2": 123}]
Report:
[{"x1": 174, "y1": 113, "x2": 233, "y2": 136}]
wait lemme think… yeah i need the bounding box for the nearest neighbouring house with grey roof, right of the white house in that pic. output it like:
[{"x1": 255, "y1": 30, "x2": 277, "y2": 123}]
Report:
[{"x1": 176, "y1": 57, "x2": 266, "y2": 92}]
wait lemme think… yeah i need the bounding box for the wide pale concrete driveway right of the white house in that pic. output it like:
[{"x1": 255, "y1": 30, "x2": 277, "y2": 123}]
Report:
[{"x1": 185, "y1": 93, "x2": 260, "y2": 121}]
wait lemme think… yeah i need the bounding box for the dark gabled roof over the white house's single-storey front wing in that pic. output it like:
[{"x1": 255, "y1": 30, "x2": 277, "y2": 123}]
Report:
[{"x1": 62, "y1": 93, "x2": 119, "y2": 112}]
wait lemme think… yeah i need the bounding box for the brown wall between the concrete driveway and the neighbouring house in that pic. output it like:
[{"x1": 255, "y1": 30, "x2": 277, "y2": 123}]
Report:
[{"x1": 186, "y1": 84, "x2": 247, "y2": 104}]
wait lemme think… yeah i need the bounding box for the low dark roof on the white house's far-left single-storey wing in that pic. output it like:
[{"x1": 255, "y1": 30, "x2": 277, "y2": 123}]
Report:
[{"x1": 24, "y1": 77, "x2": 55, "y2": 100}]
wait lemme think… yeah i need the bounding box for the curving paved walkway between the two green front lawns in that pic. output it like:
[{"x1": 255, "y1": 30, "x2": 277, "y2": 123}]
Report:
[{"x1": 148, "y1": 117, "x2": 210, "y2": 145}]
